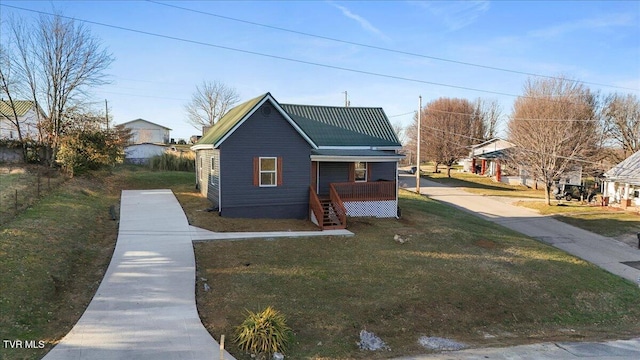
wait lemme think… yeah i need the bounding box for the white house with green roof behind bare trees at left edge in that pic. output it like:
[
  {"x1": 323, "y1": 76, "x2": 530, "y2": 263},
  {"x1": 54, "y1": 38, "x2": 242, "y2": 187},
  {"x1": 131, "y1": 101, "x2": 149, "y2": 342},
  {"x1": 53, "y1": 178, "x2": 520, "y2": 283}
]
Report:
[{"x1": 0, "y1": 100, "x2": 45, "y2": 140}]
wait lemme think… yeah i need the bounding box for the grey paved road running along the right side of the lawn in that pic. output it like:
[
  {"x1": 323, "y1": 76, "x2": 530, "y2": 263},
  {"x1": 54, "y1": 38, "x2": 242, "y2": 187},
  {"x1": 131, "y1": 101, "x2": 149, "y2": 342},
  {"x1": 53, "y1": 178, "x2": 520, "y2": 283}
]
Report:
[{"x1": 400, "y1": 174, "x2": 640, "y2": 282}]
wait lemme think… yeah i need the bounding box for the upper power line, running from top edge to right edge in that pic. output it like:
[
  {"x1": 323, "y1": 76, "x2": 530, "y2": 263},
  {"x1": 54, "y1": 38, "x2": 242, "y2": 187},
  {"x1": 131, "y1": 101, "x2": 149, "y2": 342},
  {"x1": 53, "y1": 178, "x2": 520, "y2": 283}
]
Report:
[{"x1": 147, "y1": 0, "x2": 640, "y2": 91}]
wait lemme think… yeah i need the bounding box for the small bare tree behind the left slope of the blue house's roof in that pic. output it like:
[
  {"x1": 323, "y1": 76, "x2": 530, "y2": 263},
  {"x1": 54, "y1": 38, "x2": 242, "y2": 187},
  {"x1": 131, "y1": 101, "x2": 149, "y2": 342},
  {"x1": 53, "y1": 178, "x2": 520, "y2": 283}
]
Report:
[{"x1": 185, "y1": 81, "x2": 240, "y2": 129}]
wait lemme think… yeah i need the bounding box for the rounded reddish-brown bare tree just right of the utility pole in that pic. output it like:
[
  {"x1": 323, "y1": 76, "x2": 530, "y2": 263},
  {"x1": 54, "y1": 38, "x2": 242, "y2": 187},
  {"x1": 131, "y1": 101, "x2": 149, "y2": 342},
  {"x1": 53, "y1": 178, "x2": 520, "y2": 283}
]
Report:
[{"x1": 408, "y1": 98, "x2": 485, "y2": 177}]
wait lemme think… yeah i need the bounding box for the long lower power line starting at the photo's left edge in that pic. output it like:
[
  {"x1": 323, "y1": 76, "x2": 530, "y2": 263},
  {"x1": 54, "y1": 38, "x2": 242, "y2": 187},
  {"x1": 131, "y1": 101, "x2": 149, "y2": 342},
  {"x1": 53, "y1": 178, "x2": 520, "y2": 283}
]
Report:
[{"x1": 0, "y1": 3, "x2": 588, "y2": 98}]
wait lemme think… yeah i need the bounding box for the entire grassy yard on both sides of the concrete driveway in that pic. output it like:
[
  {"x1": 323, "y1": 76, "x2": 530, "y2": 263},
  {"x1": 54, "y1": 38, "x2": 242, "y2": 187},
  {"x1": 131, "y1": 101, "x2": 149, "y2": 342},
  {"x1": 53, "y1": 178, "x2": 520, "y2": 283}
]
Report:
[{"x1": 0, "y1": 167, "x2": 640, "y2": 360}]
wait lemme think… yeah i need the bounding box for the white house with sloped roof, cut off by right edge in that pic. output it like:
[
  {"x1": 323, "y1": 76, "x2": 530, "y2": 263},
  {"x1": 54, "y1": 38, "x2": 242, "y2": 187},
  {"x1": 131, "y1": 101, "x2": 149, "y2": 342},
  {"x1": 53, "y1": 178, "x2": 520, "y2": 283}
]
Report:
[{"x1": 603, "y1": 151, "x2": 640, "y2": 208}]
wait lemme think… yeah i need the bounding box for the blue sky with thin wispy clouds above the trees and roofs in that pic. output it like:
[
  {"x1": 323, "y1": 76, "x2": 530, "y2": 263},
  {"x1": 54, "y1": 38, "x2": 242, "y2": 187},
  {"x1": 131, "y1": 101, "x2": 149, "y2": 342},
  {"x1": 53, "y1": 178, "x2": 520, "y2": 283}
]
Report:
[{"x1": 0, "y1": 0, "x2": 640, "y2": 139}]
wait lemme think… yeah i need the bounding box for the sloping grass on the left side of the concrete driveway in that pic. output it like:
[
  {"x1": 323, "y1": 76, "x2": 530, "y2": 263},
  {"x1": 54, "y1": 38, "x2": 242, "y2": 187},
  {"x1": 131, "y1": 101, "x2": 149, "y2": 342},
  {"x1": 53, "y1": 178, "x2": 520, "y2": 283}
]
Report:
[{"x1": 0, "y1": 166, "x2": 195, "y2": 360}]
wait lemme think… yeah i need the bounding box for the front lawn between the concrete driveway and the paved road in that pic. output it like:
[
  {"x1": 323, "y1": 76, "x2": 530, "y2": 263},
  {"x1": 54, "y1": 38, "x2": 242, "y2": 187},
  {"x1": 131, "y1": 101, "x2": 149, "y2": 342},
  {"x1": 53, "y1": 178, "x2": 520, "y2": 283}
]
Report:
[{"x1": 195, "y1": 192, "x2": 640, "y2": 359}]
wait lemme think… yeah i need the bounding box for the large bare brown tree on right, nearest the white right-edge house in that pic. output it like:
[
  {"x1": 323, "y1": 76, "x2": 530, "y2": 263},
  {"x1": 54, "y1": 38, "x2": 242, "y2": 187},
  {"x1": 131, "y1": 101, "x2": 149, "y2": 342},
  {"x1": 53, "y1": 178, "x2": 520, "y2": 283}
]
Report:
[{"x1": 508, "y1": 77, "x2": 598, "y2": 205}]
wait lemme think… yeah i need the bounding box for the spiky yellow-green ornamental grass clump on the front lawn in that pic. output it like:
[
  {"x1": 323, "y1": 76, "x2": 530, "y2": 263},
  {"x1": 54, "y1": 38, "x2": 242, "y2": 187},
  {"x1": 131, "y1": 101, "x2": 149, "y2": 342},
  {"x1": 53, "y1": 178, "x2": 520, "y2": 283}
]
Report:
[{"x1": 235, "y1": 306, "x2": 292, "y2": 356}]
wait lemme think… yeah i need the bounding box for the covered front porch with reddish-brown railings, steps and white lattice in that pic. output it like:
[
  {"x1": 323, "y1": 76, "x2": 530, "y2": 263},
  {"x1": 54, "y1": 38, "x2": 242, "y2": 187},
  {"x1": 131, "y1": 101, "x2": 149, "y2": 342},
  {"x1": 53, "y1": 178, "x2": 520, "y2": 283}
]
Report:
[{"x1": 309, "y1": 150, "x2": 402, "y2": 229}]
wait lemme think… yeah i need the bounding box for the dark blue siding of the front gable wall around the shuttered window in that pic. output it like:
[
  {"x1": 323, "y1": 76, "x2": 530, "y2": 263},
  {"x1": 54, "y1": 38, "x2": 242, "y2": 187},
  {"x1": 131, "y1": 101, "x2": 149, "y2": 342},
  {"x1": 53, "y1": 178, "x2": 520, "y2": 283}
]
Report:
[{"x1": 219, "y1": 102, "x2": 311, "y2": 219}]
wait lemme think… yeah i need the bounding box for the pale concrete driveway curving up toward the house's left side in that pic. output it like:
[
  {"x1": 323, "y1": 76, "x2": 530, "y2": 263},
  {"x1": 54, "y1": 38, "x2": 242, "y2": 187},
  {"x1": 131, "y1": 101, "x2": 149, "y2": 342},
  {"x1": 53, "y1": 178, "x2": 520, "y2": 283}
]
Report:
[{"x1": 44, "y1": 190, "x2": 233, "y2": 360}]
